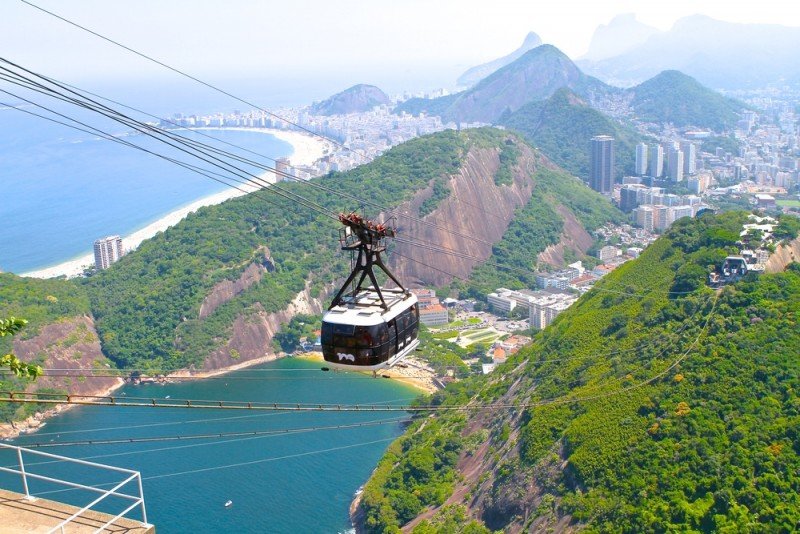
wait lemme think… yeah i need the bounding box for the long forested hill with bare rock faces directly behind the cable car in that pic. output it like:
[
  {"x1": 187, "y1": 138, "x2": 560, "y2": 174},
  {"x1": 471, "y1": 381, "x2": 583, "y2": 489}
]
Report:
[{"x1": 0, "y1": 128, "x2": 621, "y2": 384}]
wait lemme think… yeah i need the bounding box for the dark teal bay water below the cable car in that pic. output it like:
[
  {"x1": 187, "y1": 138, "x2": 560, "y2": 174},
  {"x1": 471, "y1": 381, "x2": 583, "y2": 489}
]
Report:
[{"x1": 0, "y1": 359, "x2": 417, "y2": 533}]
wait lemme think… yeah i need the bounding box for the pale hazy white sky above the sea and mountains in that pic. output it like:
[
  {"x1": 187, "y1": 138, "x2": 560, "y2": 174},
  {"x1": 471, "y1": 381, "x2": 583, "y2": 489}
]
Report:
[{"x1": 6, "y1": 0, "x2": 800, "y2": 97}]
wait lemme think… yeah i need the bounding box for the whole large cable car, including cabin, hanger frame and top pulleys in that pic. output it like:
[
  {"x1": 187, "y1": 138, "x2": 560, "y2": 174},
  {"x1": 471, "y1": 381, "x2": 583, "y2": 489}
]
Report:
[{"x1": 321, "y1": 213, "x2": 419, "y2": 371}]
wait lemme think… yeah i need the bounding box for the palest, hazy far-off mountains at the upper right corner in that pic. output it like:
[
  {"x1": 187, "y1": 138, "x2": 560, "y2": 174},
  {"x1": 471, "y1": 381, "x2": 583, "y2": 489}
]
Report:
[{"x1": 578, "y1": 15, "x2": 800, "y2": 89}]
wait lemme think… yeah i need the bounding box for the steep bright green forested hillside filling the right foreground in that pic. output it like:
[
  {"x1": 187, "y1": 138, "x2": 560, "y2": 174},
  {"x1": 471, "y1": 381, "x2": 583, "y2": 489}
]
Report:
[{"x1": 359, "y1": 212, "x2": 800, "y2": 533}]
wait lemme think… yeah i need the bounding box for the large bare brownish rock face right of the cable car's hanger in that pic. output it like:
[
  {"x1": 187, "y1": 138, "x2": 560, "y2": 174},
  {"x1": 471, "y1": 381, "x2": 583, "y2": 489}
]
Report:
[{"x1": 391, "y1": 144, "x2": 537, "y2": 286}]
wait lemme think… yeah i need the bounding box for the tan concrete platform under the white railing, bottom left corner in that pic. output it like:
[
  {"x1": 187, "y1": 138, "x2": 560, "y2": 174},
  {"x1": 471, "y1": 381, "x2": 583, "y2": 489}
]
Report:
[{"x1": 0, "y1": 489, "x2": 156, "y2": 534}]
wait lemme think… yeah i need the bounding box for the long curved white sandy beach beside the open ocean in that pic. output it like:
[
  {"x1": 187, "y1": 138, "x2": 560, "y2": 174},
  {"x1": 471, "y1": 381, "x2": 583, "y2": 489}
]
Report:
[{"x1": 21, "y1": 128, "x2": 332, "y2": 278}]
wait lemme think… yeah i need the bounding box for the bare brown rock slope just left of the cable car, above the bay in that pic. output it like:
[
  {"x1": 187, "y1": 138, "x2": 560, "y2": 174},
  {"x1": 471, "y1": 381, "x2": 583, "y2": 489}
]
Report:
[{"x1": 203, "y1": 283, "x2": 322, "y2": 371}]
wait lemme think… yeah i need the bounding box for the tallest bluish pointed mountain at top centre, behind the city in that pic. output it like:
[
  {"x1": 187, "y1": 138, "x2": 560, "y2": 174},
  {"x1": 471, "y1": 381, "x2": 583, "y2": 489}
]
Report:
[{"x1": 397, "y1": 45, "x2": 618, "y2": 123}]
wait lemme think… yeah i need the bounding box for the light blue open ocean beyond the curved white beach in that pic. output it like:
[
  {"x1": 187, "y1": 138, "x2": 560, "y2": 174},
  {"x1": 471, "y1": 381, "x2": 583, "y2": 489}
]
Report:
[{"x1": 0, "y1": 109, "x2": 292, "y2": 273}]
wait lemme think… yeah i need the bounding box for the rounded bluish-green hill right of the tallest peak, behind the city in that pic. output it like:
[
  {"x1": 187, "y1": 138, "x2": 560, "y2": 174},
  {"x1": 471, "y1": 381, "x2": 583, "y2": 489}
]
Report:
[{"x1": 628, "y1": 70, "x2": 747, "y2": 132}]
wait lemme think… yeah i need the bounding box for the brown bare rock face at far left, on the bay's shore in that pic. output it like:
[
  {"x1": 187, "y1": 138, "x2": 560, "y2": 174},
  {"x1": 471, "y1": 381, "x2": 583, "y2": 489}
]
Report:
[{"x1": 14, "y1": 317, "x2": 121, "y2": 395}]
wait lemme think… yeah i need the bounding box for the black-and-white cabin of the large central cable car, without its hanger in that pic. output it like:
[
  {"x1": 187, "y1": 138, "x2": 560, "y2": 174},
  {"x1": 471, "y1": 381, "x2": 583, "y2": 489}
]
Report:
[{"x1": 322, "y1": 288, "x2": 419, "y2": 371}]
